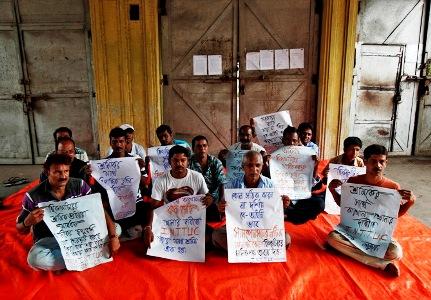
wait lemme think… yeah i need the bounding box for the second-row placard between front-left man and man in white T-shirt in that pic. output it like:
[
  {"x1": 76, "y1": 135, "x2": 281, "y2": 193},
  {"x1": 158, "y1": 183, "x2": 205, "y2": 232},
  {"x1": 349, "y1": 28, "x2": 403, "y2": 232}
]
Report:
[{"x1": 90, "y1": 157, "x2": 141, "y2": 220}]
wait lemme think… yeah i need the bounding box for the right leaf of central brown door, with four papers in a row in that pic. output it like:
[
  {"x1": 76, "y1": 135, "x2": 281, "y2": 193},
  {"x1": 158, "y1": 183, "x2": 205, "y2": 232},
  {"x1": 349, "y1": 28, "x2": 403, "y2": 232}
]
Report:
[{"x1": 239, "y1": 0, "x2": 320, "y2": 126}]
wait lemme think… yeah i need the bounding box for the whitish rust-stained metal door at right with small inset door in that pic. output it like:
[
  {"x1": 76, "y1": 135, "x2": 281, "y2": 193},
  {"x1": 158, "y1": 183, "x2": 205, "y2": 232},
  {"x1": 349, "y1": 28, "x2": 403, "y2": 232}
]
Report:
[{"x1": 351, "y1": 0, "x2": 425, "y2": 155}]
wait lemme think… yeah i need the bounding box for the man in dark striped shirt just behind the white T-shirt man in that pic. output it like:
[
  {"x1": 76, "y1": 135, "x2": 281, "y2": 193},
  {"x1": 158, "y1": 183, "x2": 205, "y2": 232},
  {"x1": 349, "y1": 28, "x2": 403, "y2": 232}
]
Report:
[{"x1": 190, "y1": 135, "x2": 226, "y2": 221}]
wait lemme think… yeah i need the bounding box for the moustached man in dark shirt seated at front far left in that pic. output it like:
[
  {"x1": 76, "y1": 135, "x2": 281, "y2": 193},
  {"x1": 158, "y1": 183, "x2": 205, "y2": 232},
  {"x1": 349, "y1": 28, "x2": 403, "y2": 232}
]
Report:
[{"x1": 16, "y1": 154, "x2": 120, "y2": 271}]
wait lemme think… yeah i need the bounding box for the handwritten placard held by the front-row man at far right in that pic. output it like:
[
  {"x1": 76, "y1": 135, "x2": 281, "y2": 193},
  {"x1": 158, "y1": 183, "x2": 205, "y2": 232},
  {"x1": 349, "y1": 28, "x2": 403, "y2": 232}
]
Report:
[{"x1": 336, "y1": 183, "x2": 401, "y2": 258}]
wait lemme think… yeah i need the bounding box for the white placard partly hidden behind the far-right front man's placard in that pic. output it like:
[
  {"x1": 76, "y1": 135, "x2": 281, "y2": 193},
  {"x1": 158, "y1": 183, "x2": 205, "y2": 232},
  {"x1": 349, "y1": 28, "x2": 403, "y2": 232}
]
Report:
[{"x1": 325, "y1": 164, "x2": 366, "y2": 215}]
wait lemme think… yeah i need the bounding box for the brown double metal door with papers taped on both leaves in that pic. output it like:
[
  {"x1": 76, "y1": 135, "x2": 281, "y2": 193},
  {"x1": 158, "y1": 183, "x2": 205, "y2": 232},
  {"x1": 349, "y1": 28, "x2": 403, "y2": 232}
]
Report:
[{"x1": 161, "y1": 0, "x2": 318, "y2": 152}]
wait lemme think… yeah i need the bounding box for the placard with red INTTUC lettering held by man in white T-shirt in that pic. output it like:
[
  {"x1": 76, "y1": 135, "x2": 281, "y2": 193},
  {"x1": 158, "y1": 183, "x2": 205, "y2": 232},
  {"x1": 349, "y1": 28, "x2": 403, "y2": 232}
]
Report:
[{"x1": 147, "y1": 195, "x2": 206, "y2": 262}]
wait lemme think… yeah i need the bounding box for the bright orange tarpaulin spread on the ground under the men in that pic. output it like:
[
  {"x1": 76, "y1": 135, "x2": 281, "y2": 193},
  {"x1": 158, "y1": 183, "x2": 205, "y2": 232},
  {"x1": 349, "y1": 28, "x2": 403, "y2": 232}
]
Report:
[{"x1": 0, "y1": 182, "x2": 431, "y2": 300}]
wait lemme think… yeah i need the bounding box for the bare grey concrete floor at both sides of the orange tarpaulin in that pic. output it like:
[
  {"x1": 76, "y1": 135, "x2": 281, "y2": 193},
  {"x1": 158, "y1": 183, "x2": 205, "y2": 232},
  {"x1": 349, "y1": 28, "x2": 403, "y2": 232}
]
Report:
[{"x1": 0, "y1": 157, "x2": 431, "y2": 227}]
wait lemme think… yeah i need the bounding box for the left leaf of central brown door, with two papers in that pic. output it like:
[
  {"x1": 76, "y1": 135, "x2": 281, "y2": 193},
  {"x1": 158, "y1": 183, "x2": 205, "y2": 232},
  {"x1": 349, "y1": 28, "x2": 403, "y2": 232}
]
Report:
[{"x1": 162, "y1": 0, "x2": 236, "y2": 153}]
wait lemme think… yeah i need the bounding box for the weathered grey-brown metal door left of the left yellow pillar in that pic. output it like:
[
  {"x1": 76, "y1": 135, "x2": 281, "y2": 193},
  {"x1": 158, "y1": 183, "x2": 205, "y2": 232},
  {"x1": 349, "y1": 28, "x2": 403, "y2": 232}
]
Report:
[{"x1": 0, "y1": 0, "x2": 96, "y2": 163}]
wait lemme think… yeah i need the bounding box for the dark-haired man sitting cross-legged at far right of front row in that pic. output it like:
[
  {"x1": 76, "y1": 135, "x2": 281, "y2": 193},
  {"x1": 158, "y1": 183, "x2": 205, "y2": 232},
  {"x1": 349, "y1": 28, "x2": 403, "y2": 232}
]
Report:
[{"x1": 328, "y1": 145, "x2": 416, "y2": 276}]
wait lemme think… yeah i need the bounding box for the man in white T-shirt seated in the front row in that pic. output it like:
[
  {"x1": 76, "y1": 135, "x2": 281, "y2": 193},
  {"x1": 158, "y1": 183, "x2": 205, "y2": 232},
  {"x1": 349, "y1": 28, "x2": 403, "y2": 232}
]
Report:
[{"x1": 143, "y1": 145, "x2": 213, "y2": 249}]
